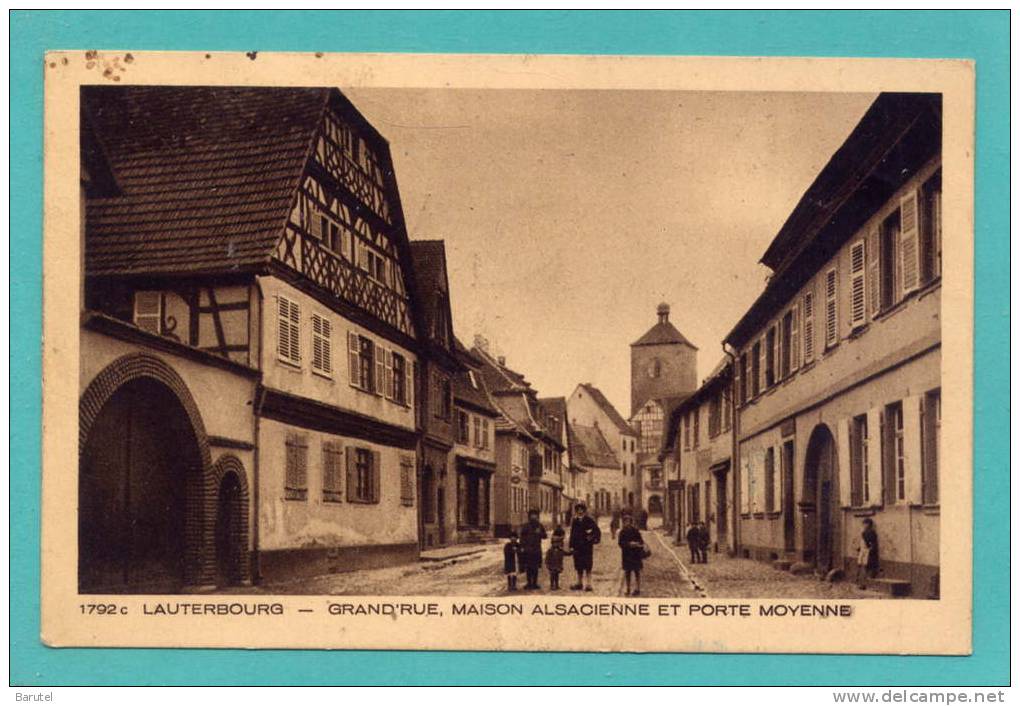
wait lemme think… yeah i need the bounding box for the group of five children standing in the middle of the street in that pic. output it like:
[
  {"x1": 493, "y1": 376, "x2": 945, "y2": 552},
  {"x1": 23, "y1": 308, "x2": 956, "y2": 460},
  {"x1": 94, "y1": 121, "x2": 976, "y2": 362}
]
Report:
[{"x1": 503, "y1": 503, "x2": 651, "y2": 596}]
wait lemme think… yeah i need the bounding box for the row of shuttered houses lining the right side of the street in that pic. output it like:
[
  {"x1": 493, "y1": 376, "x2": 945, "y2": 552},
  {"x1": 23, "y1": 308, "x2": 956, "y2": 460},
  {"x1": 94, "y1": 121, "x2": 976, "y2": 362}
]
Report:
[{"x1": 658, "y1": 94, "x2": 941, "y2": 598}]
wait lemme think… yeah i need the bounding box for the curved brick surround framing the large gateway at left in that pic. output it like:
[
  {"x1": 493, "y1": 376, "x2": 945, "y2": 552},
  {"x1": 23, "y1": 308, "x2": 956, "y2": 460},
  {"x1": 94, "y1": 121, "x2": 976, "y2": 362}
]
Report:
[{"x1": 78, "y1": 353, "x2": 218, "y2": 591}]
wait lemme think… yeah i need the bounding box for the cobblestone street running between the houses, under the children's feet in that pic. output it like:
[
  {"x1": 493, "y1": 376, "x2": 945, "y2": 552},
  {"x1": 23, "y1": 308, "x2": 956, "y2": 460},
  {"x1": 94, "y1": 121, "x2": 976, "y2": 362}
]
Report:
[{"x1": 244, "y1": 522, "x2": 885, "y2": 600}]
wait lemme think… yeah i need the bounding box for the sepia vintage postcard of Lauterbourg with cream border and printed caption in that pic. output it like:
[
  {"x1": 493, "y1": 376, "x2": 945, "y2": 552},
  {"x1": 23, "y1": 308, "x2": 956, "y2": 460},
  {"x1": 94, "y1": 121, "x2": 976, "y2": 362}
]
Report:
[{"x1": 42, "y1": 50, "x2": 974, "y2": 654}]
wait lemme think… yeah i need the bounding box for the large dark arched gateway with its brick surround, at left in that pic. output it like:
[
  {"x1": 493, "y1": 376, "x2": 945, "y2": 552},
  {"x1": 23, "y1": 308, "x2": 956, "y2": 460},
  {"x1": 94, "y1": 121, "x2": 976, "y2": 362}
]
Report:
[{"x1": 79, "y1": 353, "x2": 217, "y2": 593}]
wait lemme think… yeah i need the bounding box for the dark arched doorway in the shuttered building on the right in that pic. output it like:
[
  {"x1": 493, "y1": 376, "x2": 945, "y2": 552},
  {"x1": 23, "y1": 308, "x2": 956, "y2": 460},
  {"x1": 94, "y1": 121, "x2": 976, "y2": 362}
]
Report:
[{"x1": 800, "y1": 424, "x2": 838, "y2": 572}]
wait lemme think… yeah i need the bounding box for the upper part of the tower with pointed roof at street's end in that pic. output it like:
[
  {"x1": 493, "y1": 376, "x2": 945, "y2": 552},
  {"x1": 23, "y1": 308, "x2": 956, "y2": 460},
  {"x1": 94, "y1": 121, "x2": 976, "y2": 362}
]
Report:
[{"x1": 630, "y1": 302, "x2": 698, "y2": 415}]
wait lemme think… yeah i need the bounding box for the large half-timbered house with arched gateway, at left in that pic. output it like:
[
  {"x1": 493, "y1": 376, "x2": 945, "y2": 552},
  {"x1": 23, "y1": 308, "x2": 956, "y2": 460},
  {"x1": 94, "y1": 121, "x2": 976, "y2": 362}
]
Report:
[{"x1": 79, "y1": 87, "x2": 420, "y2": 593}]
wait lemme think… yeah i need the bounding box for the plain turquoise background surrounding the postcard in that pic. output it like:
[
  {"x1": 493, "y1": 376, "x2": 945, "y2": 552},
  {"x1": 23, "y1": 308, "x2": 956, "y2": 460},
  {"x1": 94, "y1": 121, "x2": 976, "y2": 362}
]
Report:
[{"x1": 9, "y1": 10, "x2": 1010, "y2": 686}]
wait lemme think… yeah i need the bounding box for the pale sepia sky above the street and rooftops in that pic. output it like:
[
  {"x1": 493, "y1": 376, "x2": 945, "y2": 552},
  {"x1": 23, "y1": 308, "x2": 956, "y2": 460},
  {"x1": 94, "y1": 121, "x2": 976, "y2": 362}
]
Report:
[{"x1": 343, "y1": 88, "x2": 875, "y2": 416}]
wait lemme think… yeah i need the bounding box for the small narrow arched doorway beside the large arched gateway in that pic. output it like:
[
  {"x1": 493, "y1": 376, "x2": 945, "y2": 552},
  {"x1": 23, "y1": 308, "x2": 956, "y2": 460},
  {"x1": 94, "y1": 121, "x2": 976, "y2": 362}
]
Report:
[{"x1": 214, "y1": 455, "x2": 251, "y2": 587}]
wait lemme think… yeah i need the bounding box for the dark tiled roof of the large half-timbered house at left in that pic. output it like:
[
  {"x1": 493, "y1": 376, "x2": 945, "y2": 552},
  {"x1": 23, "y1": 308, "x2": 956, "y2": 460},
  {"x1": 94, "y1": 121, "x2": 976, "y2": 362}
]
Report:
[{"x1": 82, "y1": 86, "x2": 329, "y2": 274}]
